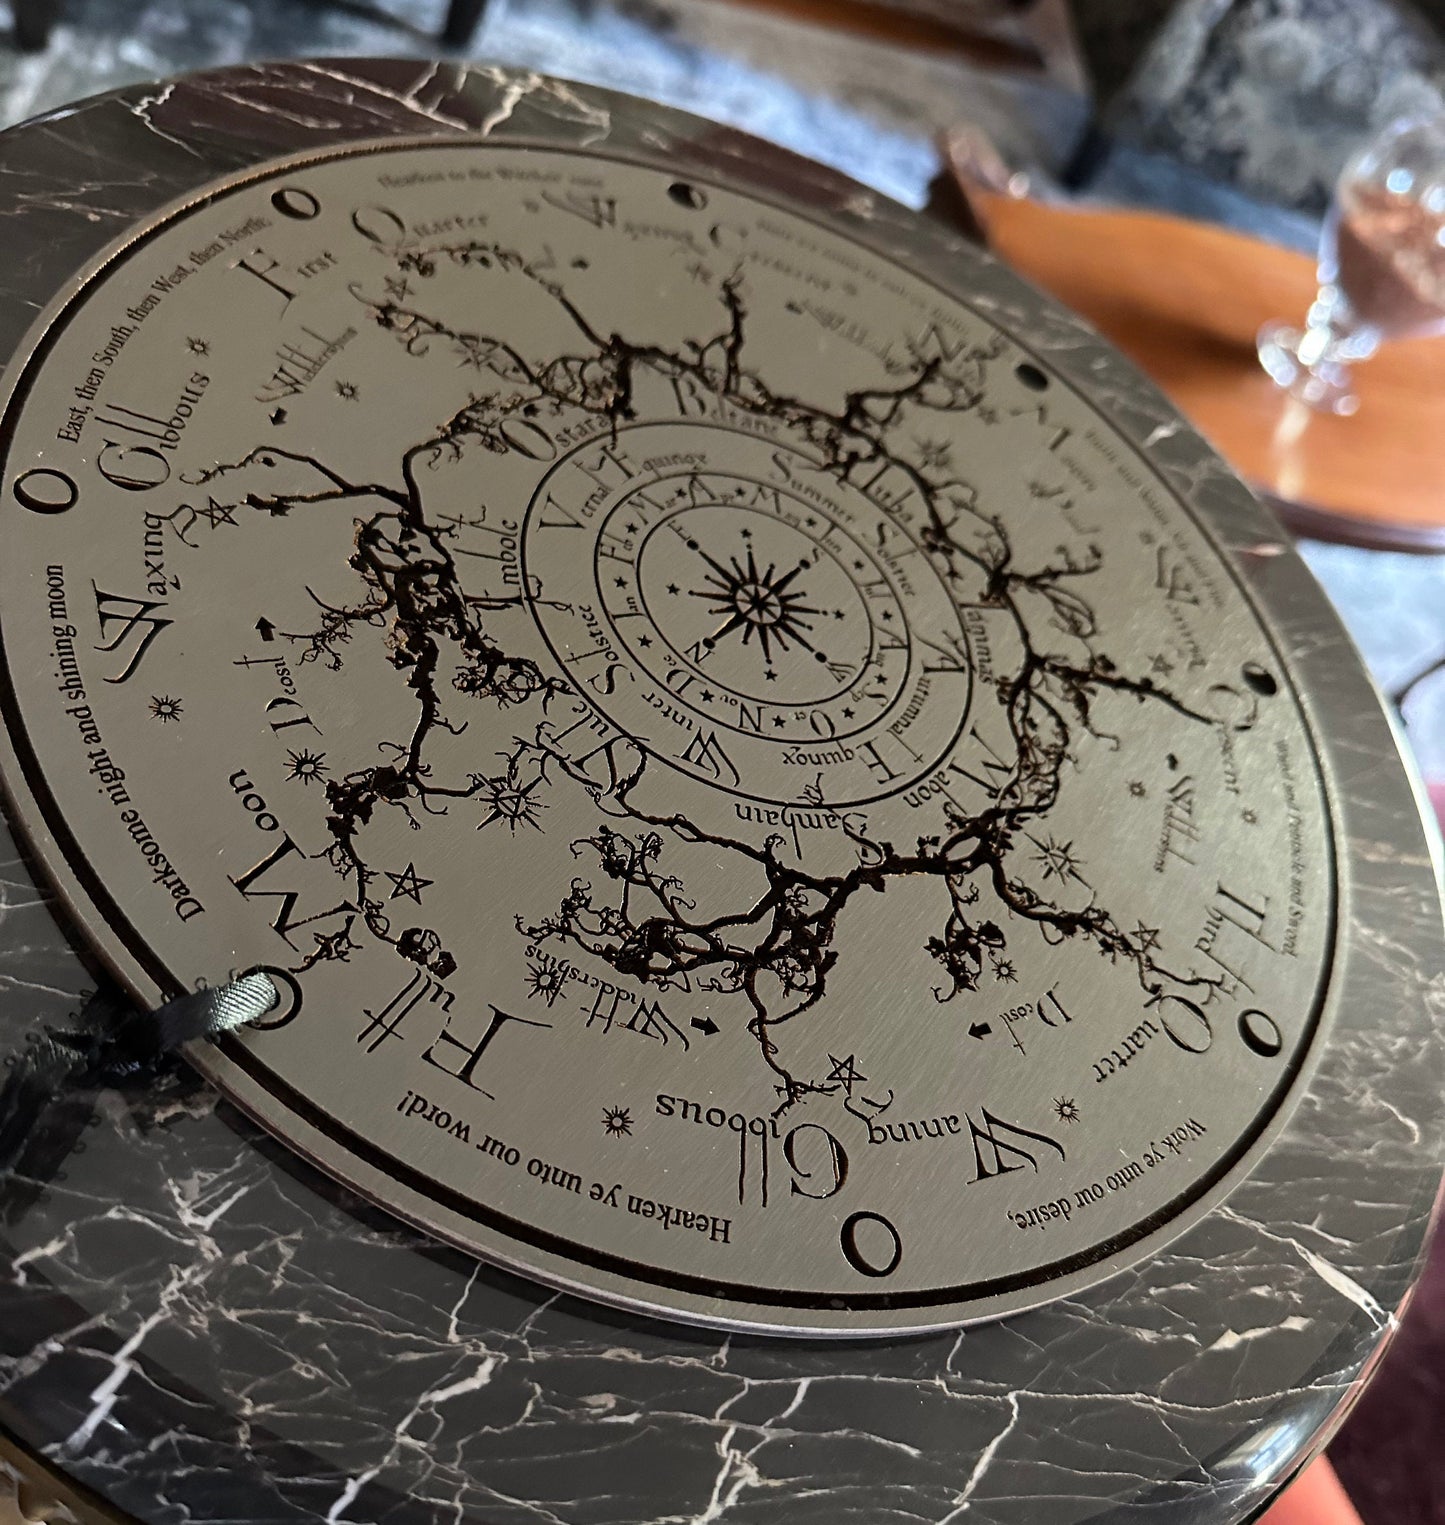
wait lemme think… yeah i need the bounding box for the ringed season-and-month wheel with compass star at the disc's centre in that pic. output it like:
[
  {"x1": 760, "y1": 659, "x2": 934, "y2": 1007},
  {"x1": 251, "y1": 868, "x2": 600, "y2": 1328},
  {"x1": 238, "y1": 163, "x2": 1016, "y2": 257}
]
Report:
[{"x1": 521, "y1": 422, "x2": 972, "y2": 805}]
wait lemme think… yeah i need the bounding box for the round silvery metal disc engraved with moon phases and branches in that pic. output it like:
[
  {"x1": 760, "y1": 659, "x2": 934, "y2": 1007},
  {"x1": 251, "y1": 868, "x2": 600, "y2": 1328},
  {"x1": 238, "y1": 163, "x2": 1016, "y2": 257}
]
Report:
[{"x1": 0, "y1": 140, "x2": 1334, "y2": 1334}]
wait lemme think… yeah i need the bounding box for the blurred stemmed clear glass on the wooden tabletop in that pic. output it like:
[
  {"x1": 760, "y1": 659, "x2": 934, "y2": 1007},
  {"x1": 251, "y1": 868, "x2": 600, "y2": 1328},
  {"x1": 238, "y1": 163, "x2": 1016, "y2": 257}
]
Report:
[{"x1": 1259, "y1": 113, "x2": 1445, "y2": 413}]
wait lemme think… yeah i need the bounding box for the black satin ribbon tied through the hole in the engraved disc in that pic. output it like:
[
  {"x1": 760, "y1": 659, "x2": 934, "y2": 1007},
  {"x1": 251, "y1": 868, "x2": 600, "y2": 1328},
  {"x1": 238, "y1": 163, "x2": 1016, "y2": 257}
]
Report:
[{"x1": 0, "y1": 971, "x2": 279, "y2": 1220}]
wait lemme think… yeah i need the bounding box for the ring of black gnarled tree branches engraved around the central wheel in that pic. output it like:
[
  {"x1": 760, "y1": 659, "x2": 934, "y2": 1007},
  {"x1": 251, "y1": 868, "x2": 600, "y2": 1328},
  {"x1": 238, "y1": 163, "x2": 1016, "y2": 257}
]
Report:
[{"x1": 185, "y1": 241, "x2": 1219, "y2": 1107}]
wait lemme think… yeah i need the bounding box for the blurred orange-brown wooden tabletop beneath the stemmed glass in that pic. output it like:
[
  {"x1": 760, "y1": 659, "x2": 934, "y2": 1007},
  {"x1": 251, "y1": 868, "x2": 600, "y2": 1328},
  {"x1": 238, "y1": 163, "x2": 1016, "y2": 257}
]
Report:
[{"x1": 954, "y1": 159, "x2": 1445, "y2": 551}]
